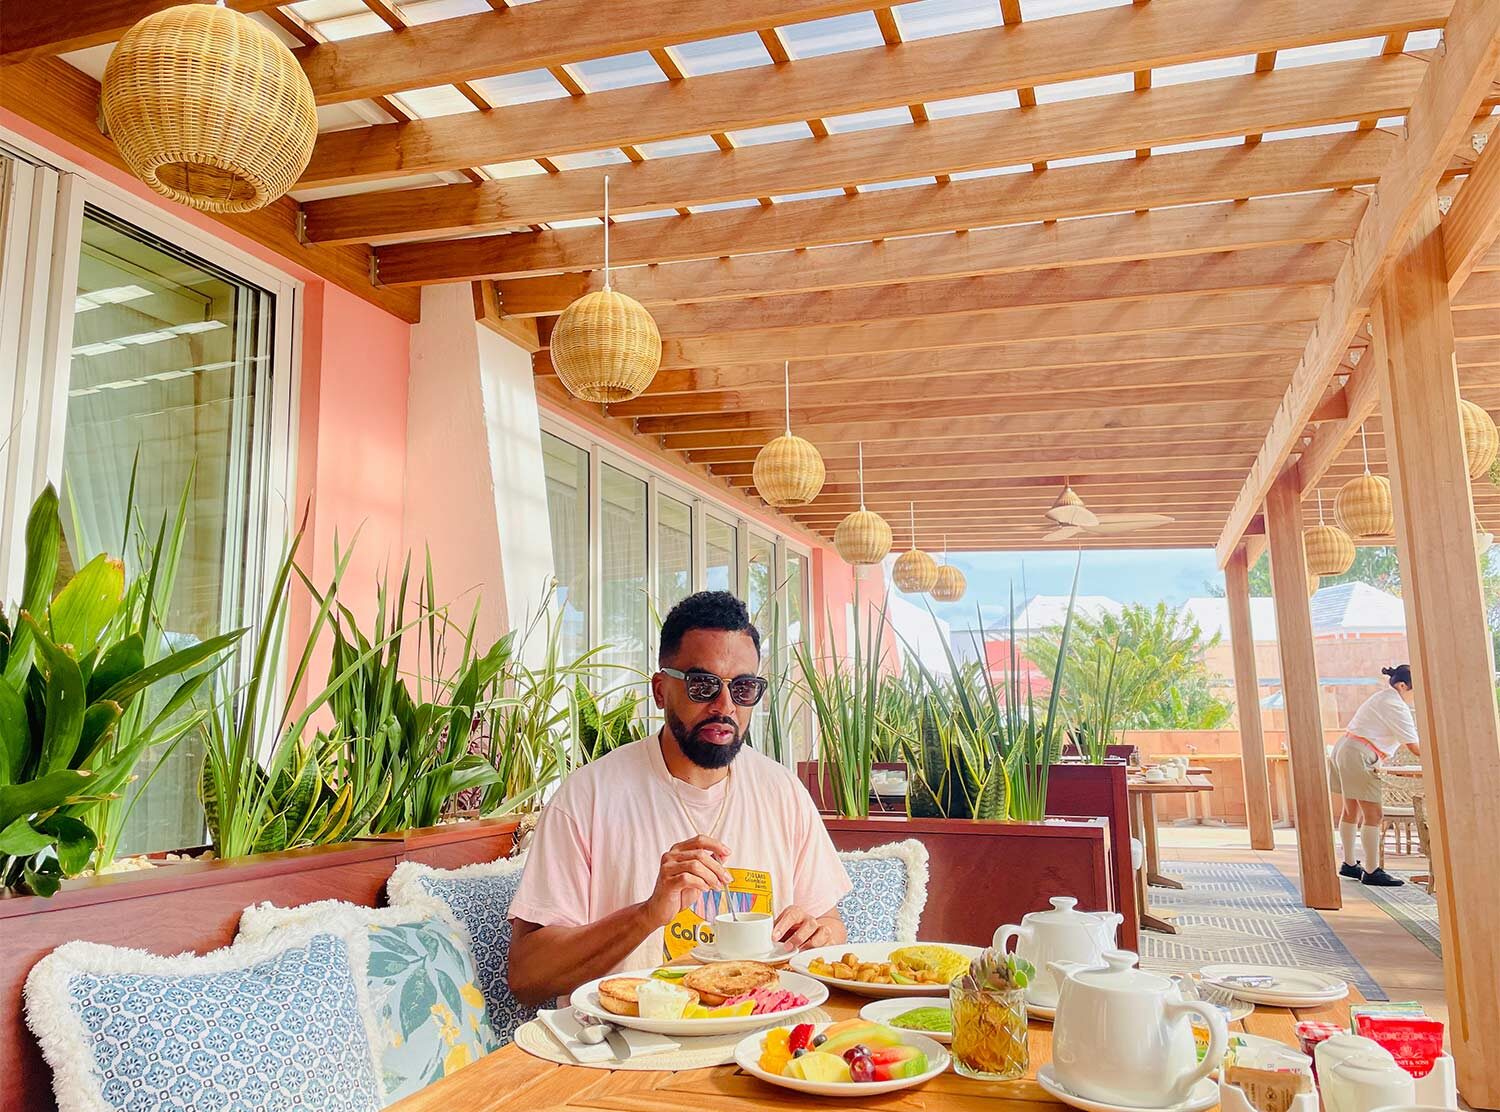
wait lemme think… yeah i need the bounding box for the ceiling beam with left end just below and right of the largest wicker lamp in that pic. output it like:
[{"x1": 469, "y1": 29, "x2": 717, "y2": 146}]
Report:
[{"x1": 302, "y1": 56, "x2": 1427, "y2": 228}]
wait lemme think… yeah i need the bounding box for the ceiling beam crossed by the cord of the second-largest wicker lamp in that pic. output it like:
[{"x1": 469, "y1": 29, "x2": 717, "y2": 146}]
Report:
[{"x1": 377, "y1": 132, "x2": 1397, "y2": 290}]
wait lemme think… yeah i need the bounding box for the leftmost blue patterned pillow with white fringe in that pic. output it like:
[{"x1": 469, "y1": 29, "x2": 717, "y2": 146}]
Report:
[{"x1": 26, "y1": 930, "x2": 381, "y2": 1112}]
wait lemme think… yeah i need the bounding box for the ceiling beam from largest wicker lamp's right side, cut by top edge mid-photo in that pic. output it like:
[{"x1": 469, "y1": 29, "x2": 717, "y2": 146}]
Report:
[{"x1": 297, "y1": 0, "x2": 869, "y2": 105}]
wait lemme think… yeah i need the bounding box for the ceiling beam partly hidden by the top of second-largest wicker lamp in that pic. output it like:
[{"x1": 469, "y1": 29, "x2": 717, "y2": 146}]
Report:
[{"x1": 494, "y1": 191, "x2": 1374, "y2": 317}]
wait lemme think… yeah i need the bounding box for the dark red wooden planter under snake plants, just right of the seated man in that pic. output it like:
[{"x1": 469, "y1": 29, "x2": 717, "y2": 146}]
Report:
[{"x1": 824, "y1": 815, "x2": 1130, "y2": 945}]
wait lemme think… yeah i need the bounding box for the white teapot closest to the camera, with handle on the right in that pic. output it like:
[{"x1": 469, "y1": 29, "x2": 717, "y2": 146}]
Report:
[{"x1": 1052, "y1": 950, "x2": 1229, "y2": 1107}]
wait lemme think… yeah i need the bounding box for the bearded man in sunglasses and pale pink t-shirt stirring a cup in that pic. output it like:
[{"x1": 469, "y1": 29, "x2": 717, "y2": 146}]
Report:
[{"x1": 510, "y1": 591, "x2": 852, "y2": 1004}]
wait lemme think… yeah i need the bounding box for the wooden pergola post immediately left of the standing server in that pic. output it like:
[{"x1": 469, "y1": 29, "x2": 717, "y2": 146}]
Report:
[{"x1": 1266, "y1": 471, "x2": 1344, "y2": 911}]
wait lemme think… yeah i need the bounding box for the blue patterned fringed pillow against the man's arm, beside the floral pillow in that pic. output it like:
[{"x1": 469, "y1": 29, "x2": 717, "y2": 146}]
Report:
[{"x1": 386, "y1": 860, "x2": 537, "y2": 1043}]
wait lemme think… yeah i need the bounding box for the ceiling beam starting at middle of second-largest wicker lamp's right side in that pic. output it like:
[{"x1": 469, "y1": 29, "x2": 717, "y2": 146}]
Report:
[{"x1": 639, "y1": 286, "x2": 1326, "y2": 368}]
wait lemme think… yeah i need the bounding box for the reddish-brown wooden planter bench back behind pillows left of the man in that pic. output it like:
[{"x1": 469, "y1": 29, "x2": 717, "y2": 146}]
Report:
[{"x1": 0, "y1": 818, "x2": 518, "y2": 1112}]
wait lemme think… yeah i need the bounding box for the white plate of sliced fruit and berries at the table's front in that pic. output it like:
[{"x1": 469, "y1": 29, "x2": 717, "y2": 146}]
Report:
[{"x1": 735, "y1": 1019, "x2": 948, "y2": 1097}]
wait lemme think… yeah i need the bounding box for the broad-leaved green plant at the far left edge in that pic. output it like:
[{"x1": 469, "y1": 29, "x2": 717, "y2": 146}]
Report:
[{"x1": 0, "y1": 486, "x2": 243, "y2": 896}]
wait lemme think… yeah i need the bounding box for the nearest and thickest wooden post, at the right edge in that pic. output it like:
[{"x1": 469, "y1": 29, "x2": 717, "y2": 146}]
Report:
[{"x1": 1371, "y1": 201, "x2": 1500, "y2": 1109}]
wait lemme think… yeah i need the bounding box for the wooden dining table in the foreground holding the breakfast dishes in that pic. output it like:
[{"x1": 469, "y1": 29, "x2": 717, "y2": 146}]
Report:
[{"x1": 389, "y1": 990, "x2": 1359, "y2": 1112}]
